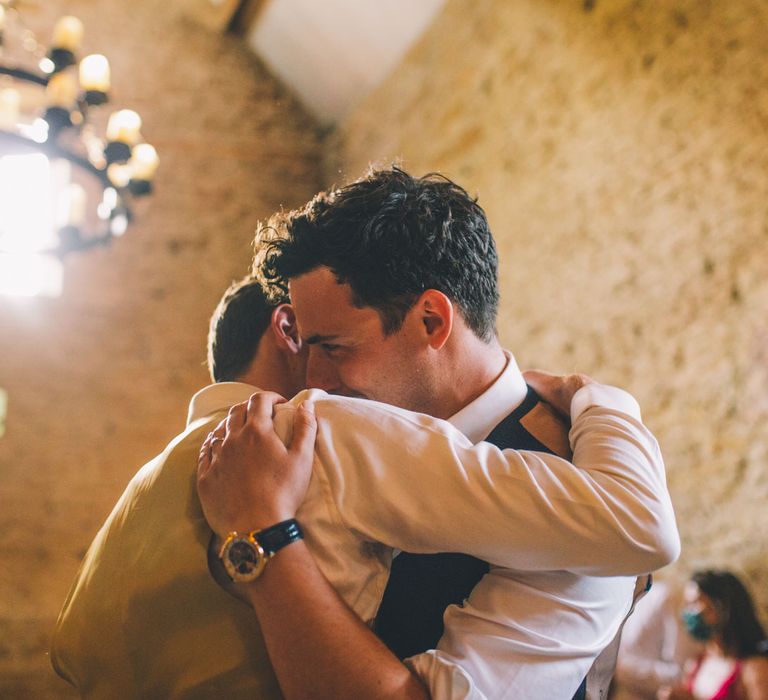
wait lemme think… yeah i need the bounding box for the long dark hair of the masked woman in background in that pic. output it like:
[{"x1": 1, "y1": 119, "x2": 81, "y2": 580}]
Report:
[{"x1": 691, "y1": 569, "x2": 765, "y2": 659}]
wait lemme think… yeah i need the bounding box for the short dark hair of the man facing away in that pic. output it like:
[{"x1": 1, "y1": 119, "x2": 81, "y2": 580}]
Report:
[{"x1": 208, "y1": 275, "x2": 288, "y2": 382}]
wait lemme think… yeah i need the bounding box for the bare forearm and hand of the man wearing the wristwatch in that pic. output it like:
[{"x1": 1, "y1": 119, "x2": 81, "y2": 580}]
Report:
[{"x1": 198, "y1": 394, "x2": 429, "y2": 700}]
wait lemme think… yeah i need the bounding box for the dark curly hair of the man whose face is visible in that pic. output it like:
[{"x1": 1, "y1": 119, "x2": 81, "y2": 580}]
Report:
[{"x1": 254, "y1": 167, "x2": 499, "y2": 341}]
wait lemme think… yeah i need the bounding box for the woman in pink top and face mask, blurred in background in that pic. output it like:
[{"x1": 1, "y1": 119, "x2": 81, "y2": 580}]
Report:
[{"x1": 657, "y1": 569, "x2": 768, "y2": 700}]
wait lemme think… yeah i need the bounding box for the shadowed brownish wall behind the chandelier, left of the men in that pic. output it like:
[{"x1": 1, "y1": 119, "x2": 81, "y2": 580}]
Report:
[{"x1": 0, "y1": 0, "x2": 319, "y2": 700}]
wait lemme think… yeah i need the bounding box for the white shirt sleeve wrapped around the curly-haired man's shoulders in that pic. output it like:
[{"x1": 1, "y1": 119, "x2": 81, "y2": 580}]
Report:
[{"x1": 300, "y1": 384, "x2": 680, "y2": 576}]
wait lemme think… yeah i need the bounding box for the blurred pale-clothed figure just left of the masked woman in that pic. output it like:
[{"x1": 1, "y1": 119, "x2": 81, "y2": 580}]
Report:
[{"x1": 611, "y1": 579, "x2": 701, "y2": 700}]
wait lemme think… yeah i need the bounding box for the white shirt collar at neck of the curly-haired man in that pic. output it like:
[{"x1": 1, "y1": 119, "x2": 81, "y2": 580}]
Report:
[{"x1": 448, "y1": 350, "x2": 528, "y2": 442}]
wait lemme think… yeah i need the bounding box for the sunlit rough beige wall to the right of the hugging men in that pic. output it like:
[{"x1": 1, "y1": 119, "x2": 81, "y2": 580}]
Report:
[{"x1": 327, "y1": 0, "x2": 768, "y2": 611}]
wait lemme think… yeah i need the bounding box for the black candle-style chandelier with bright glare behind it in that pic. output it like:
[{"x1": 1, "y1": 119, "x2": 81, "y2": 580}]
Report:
[{"x1": 0, "y1": 0, "x2": 158, "y2": 295}]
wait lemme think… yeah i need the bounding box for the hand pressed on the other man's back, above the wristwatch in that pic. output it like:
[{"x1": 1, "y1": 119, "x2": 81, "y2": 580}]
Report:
[{"x1": 197, "y1": 392, "x2": 317, "y2": 538}]
